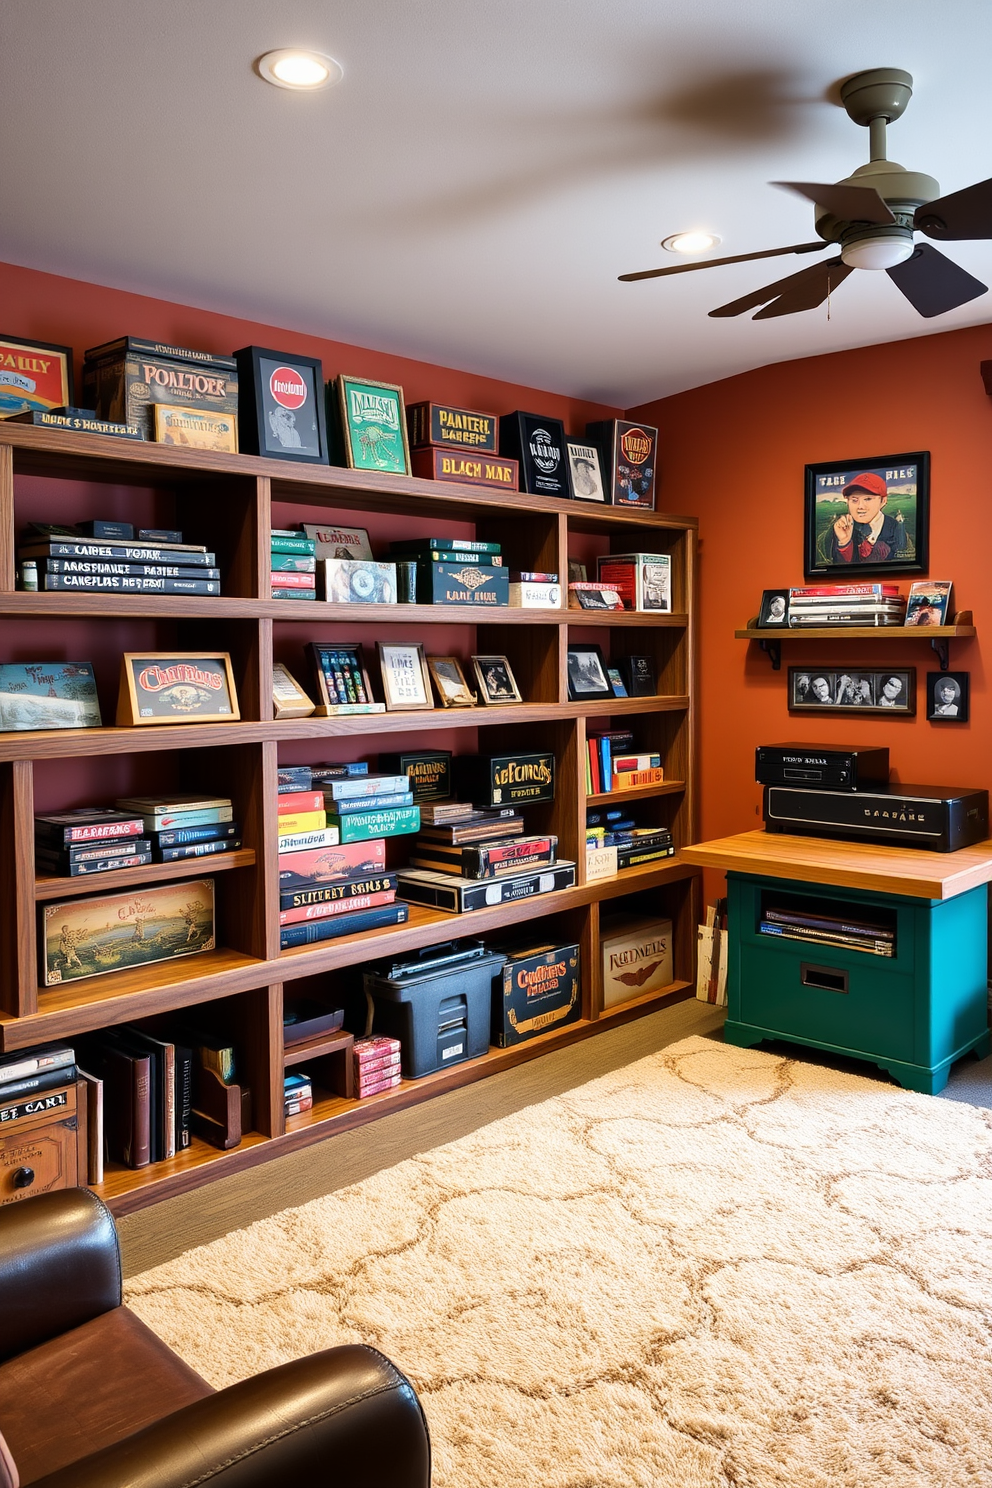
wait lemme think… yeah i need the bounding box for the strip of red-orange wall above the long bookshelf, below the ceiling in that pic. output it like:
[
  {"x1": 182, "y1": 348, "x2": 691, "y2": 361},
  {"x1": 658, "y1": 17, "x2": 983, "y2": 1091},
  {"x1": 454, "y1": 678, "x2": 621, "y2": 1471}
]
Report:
[{"x1": 0, "y1": 263, "x2": 620, "y2": 433}]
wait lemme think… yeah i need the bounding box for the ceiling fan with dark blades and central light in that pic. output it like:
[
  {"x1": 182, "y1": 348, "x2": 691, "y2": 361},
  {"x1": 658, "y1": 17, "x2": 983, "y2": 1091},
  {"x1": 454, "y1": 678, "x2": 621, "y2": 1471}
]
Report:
[{"x1": 620, "y1": 67, "x2": 992, "y2": 320}]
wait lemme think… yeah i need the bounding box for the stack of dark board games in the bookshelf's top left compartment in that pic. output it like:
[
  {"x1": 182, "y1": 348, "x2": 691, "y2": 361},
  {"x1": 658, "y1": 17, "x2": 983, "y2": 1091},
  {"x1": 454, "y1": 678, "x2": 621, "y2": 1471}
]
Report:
[{"x1": 18, "y1": 521, "x2": 220, "y2": 595}]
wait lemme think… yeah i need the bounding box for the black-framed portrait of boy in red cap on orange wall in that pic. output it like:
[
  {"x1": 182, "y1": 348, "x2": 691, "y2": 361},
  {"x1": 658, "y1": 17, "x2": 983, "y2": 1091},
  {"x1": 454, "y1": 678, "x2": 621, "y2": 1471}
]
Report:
[{"x1": 805, "y1": 449, "x2": 930, "y2": 583}]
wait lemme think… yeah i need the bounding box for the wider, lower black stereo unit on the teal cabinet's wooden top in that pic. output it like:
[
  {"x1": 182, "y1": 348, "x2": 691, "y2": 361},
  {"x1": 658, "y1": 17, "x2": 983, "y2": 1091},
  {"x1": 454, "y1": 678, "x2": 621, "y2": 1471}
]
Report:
[{"x1": 764, "y1": 784, "x2": 989, "y2": 853}]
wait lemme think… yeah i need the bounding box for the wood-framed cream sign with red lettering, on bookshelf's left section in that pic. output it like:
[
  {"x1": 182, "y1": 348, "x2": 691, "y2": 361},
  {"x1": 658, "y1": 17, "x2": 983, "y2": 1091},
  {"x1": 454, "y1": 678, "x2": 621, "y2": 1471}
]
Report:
[{"x1": 117, "y1": 652, "x2": 241, "y2": 728}]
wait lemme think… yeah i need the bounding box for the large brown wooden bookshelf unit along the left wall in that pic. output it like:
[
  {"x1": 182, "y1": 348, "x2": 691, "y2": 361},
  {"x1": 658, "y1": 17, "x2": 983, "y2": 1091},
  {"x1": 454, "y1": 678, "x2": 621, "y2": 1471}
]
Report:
[{"x1": 0, "y1": 423, "x2": 700, "y2": 1214}]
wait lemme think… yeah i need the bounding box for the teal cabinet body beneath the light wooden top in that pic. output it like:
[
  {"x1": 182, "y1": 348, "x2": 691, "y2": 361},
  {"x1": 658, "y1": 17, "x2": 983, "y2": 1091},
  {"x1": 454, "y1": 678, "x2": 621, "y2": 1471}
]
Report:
[{"x1": 724, "y1": 872, "x2": 989, "y2": 1095}]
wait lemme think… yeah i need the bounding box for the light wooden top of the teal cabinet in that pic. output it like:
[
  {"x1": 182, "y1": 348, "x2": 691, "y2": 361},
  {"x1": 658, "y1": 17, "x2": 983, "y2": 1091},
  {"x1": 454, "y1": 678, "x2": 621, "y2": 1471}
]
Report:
[{"x1": 681, "y1": 832, "x2": 992, "y2": 899}]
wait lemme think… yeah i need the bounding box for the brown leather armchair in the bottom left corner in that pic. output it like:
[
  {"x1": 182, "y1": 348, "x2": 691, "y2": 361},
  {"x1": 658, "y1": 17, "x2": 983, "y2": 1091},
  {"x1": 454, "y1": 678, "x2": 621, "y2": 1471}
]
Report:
[{"x1": 0, "y1": 1189, "x2": 430, "y2": 1488}]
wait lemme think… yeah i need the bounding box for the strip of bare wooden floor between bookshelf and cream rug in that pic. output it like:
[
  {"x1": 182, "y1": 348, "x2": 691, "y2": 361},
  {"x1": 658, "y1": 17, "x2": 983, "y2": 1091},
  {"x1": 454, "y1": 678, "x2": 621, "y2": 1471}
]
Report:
[{"x1": 117, "y1": 998, "x2": 724, "y2": 1275}]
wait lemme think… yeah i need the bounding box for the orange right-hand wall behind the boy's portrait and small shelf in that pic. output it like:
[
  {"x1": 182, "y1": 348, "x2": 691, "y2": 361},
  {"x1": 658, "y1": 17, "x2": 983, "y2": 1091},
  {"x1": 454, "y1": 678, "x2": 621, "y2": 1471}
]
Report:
[{"x1": 635, "y1": 326, "x2": 992, "y2": 838}]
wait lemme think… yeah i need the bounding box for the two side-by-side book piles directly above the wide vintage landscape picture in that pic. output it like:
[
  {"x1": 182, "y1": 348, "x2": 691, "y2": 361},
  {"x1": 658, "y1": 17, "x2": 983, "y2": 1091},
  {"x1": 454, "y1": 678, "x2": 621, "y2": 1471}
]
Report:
[{"x1": 34, "y1": 795, "x2": 241, "y2": 878}]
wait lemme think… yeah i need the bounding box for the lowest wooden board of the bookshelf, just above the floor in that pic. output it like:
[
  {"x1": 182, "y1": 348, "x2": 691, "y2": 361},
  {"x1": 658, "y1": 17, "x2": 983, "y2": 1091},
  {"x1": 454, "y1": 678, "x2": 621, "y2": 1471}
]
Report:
[{"x1": 95, "y1": 982, "x2": 693, "y2": 1216}]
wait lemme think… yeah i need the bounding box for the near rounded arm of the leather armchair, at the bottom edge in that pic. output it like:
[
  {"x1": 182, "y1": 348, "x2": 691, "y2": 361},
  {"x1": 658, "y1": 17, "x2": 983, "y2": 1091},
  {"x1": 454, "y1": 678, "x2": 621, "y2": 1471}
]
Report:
[{"x1": 31, "y1": 1344, "x2": 430, "y2": 1488}]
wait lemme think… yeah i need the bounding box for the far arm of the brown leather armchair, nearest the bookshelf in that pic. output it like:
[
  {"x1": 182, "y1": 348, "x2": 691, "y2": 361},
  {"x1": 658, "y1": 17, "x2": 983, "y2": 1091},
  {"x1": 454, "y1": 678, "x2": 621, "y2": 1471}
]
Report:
[{"x1": 0, "y1": 1189, "x2": 120, "y2": 1362}]
